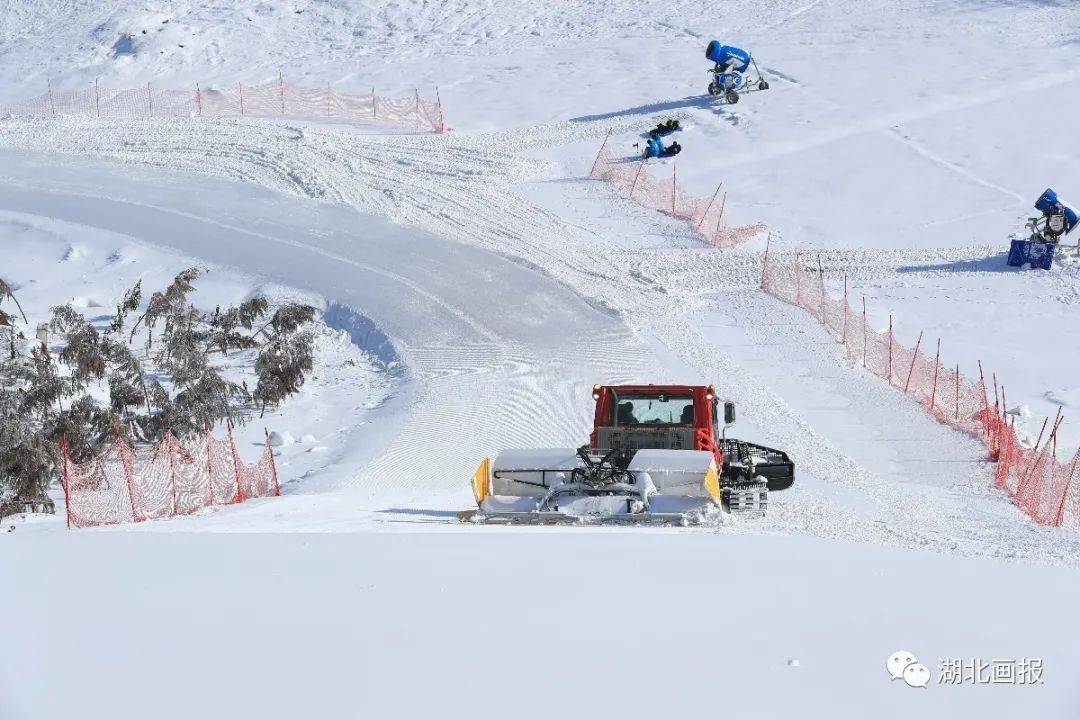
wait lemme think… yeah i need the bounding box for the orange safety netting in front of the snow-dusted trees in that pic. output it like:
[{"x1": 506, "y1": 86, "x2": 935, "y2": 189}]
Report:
[{"x1": 63, "y1": 431, "x2": 281, "y2": 528}]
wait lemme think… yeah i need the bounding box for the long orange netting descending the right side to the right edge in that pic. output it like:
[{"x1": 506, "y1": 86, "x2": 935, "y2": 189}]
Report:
[{"x1": 761, "y1": 250, "x2": 1080, "y2": 527}]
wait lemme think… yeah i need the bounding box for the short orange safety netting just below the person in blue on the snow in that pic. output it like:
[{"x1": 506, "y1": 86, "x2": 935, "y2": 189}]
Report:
[{"x1": 589, "y1": 133, "x2": 766, "y2": 247}]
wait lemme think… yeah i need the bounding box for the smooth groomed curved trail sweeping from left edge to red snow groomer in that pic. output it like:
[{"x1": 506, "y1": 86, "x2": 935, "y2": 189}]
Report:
[{"x1": 0, "y1": 157, "x2": 654, "y2": 511}]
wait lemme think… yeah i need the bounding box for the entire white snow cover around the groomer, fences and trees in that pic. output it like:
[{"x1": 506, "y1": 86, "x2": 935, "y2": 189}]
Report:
[{"x1": 6, "y1": 0, "x2": 1080, "y2": 720}]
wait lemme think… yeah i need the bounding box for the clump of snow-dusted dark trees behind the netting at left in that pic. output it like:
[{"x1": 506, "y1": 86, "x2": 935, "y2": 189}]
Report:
[{"x1": 0, "y1": 268, "x2": 315, "y2": 502}]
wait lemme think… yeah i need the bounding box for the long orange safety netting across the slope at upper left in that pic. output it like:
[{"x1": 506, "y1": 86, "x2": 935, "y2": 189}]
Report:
[{"x1": 0, "y1": 79, "x2": 446, "y2": 133}]
